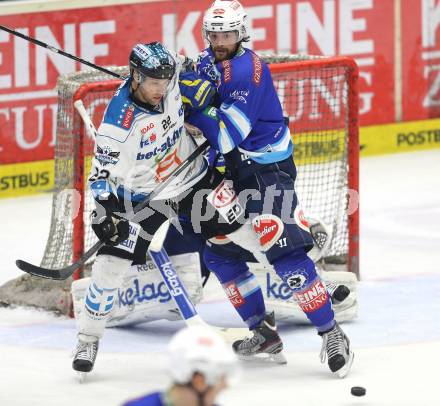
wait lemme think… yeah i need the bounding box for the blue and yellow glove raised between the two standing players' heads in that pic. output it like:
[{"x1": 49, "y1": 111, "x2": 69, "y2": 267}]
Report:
[{"x1": 179, "y1": 71, "x2": 216, "y2": 110}]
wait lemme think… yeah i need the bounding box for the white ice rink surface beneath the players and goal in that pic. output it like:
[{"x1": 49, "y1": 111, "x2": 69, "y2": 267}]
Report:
[{"x1": 0, "y1": 150, "x2": 440, "y2": 406}]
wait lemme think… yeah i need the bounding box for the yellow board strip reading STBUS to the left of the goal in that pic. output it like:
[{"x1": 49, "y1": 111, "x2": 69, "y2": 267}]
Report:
[{"x1": 0, "y1": 160, "x2": 54, "y2": 198}]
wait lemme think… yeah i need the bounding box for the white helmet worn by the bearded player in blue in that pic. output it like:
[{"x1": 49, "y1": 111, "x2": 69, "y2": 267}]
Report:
[{"x1": 202, "y1": 0, "x2": 249, "y2": 42}]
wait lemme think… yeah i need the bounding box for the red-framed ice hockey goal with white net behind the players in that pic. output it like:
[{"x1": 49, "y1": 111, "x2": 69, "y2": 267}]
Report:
[{"x1": 0, "y1": 55, "x2": 359, "y2": 313}]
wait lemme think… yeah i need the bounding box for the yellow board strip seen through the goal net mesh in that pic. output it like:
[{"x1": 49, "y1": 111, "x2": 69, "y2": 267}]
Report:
[{"x1": 292, "y1": 129, "x2": 347, "y2": 166}]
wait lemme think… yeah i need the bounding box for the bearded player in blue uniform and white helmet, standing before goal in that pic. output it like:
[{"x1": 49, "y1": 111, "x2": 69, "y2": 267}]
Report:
[{"x1": 187, "y1": 0, "x2": 353, "y2": 377}]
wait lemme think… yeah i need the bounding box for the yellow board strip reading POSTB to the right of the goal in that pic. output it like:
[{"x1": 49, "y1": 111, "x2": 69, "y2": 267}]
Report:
[{"x1": 360, "y1": 118, "x2": 440, "y2": 157}]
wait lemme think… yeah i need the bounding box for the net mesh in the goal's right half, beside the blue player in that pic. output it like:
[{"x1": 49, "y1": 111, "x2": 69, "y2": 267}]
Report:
[{"x1": 273, "y1": 67, "x2": 348, "y2": 261}]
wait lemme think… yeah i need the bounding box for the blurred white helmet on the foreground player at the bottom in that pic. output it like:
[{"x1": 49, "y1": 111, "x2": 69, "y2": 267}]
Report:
[{"x1": 168, "y1": 326, "x2": 237, "y2": 386}]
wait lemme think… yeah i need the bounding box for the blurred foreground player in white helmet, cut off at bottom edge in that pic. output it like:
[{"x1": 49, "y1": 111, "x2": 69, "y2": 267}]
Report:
[{"x1": 124, "y1": 327, "x2": 237, "y2": 406}]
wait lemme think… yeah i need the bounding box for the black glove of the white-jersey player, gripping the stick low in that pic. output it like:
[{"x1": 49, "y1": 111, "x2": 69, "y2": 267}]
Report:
[{"x1": 92, "y1": 210, "x2": 129, "y2": 246}]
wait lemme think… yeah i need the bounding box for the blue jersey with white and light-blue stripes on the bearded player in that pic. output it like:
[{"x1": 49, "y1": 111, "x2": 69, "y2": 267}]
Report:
[{"x1": 187, "y1": 48, "x2": 293, "y2": 164}]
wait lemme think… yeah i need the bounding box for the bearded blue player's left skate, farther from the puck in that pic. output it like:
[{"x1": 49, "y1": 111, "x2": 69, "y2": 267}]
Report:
[{"x1": 232, "y1": 312, "x2": 287, "y2": 364}]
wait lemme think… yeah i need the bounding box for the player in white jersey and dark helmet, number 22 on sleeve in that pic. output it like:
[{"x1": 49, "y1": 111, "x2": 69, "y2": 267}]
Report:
[{"x1": 73, "y1": 42, "x2": 227, "y2": 372}]
